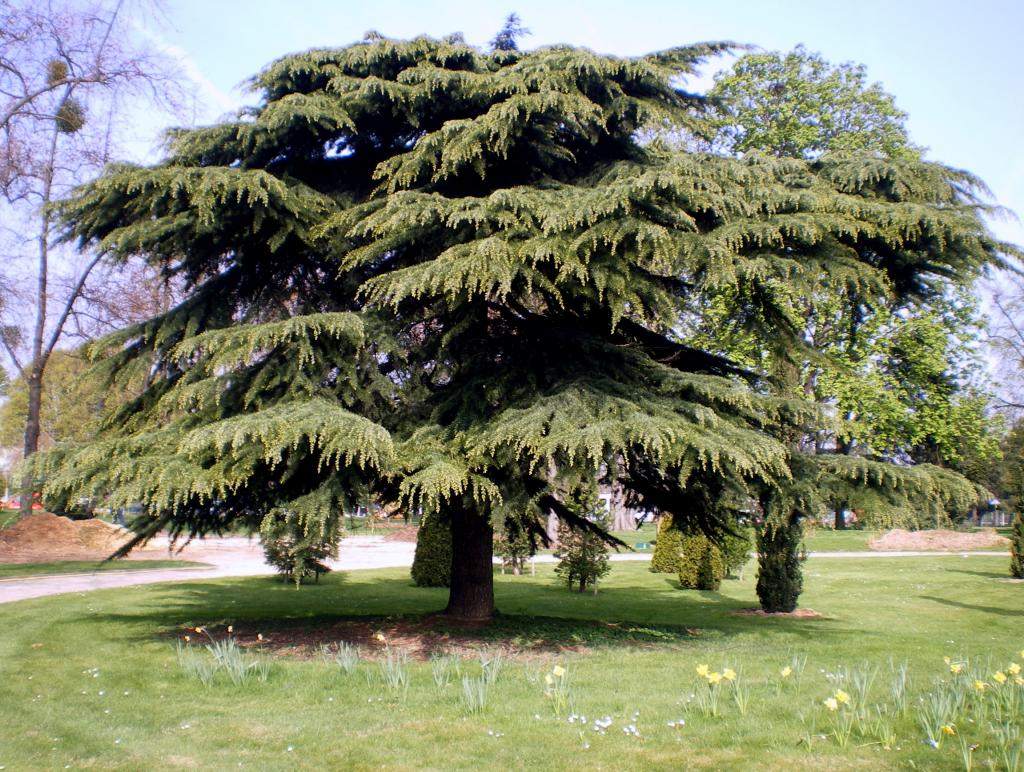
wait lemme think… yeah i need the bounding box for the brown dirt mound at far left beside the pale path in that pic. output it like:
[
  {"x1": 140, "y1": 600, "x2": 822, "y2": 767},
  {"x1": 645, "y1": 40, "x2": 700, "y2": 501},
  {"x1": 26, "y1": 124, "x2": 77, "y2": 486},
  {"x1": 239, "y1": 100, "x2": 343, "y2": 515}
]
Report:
[{"x1": 0, "y1": 512, "x2": 144, "y2": 562}]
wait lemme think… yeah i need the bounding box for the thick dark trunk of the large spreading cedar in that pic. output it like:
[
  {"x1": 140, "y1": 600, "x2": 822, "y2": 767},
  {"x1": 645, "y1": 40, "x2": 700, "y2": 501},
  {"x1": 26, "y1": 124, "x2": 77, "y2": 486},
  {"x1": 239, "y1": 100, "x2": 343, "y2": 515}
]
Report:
[{"x1": 444, "y1": 503, "x2": 495, "y2": 620}]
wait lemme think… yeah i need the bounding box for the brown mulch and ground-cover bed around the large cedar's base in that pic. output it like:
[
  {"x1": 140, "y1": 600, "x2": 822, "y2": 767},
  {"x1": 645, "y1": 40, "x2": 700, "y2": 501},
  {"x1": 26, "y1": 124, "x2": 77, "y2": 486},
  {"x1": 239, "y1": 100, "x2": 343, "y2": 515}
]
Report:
[{"x1": 174, "y1": 614, "x2": 702, "y2": 661}]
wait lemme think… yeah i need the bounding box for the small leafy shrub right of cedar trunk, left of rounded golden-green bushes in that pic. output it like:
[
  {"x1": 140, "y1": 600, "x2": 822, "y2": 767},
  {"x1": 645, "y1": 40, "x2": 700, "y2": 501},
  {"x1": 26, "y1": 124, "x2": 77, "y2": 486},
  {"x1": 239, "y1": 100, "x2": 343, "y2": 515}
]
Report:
[{"x1": 555, "y1": 485, "x2": 611, "y2": 593}]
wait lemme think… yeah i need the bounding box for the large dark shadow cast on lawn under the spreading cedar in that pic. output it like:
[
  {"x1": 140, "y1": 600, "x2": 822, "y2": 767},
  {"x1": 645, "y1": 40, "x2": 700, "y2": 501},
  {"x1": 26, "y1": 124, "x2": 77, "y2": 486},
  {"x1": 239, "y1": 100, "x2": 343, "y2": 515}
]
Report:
[{"x1": 74, "y1": 574, "x2": 842, "y2": 659}]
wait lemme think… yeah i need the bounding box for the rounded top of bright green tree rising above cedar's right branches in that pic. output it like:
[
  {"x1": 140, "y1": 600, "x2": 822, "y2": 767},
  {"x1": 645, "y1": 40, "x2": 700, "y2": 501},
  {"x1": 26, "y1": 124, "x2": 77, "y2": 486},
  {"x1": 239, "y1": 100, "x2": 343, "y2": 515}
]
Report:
[{"x1": 709, "y1": 46, "x2": 920, "y2": 158}]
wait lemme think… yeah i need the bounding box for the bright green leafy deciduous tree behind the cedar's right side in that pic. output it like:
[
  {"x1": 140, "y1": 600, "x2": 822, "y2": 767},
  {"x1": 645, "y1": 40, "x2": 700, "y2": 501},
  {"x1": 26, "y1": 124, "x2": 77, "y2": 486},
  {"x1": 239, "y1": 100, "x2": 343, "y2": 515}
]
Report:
[{"x1": 700, "y1": 47, "x2": 997, "y2": 481}]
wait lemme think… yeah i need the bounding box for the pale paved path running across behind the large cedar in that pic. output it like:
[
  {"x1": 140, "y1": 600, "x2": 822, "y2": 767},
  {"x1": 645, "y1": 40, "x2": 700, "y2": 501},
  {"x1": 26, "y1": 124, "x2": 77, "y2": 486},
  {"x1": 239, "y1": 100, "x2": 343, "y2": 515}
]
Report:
[{"x1": 0, "y1": 537, "x2": 1010, "y2": 603}]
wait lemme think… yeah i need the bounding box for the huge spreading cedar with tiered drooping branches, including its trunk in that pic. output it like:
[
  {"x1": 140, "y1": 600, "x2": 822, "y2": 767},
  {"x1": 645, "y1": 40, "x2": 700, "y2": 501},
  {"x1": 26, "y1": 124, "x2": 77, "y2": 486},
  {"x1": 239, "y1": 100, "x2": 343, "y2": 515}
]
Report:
[{"x1": 41, "y1": 35, "x2": 1015, "y2": 617}]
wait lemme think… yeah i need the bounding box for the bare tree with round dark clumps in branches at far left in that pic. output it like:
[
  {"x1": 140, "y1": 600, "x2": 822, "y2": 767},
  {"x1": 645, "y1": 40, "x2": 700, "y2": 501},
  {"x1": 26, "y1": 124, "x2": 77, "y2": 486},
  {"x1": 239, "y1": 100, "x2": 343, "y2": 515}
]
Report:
[{"x1": 0, "y1": 0, "x2": 177, "y2": 512}]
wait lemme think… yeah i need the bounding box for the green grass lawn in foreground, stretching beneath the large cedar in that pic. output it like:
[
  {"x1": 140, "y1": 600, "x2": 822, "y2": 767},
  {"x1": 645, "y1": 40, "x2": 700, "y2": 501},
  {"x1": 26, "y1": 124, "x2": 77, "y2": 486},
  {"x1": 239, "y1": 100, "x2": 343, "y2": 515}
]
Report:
[{"x1": 0, "y1": 557, "x2": 1024, "y2": 770}]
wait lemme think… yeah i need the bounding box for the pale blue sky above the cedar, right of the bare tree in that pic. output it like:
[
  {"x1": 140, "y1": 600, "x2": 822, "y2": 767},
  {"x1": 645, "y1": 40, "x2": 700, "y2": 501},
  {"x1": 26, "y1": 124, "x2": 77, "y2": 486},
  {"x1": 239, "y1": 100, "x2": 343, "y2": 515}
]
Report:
[{"x1": 146, "y1": 0, "x2": 1024, "y2": 244}]
